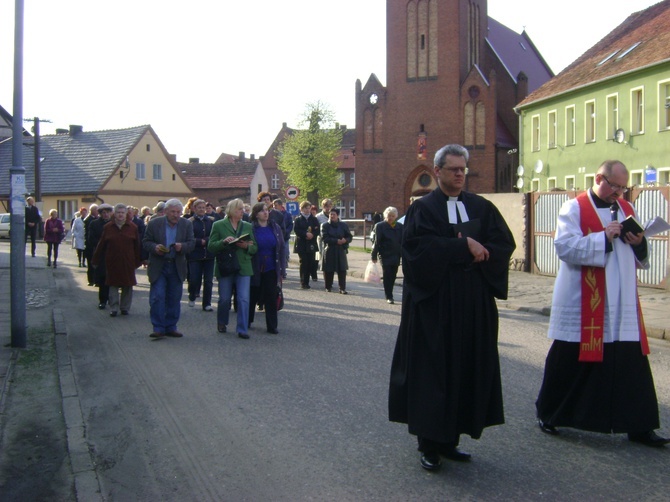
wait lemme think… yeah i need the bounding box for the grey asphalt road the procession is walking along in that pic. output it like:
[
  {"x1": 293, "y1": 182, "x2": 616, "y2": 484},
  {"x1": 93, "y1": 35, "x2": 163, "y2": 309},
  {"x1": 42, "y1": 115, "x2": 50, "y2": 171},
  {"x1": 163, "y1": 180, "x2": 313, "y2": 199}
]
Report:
[{"x1": 5, "y1": 245, "x2": 670, "y2": 501}]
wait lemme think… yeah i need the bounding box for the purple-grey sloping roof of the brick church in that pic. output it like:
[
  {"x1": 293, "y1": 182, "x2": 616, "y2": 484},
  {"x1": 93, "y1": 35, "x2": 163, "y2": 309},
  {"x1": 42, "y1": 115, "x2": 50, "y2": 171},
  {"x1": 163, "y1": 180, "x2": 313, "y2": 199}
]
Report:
[{"x1": 486, "y1": 17, "x2": 554, "y2": 92}]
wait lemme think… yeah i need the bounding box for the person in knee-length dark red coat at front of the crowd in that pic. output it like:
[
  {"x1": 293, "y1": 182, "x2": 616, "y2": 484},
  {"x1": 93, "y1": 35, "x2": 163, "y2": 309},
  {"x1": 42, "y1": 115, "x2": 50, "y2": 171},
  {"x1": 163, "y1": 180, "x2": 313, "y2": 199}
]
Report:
[{"x1": 93, "y1": 204, "x2": 142, "y2": 317}]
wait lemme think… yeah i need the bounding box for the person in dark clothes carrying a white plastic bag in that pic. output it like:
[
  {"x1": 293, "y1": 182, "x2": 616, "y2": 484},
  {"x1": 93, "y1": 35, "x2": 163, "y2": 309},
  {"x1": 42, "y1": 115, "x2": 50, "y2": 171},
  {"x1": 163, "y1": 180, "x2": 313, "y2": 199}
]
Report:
[{"x1": 371, "y1": 206, "x2": 402, "y2": 305}]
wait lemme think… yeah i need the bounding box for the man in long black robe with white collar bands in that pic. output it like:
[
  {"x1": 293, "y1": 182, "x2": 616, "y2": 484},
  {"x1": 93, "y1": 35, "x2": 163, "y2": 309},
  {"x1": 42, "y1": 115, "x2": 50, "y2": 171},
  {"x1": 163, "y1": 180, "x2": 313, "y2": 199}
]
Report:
[{"x1": 389, "y1": 145, "x2": 515, "y2": 470}]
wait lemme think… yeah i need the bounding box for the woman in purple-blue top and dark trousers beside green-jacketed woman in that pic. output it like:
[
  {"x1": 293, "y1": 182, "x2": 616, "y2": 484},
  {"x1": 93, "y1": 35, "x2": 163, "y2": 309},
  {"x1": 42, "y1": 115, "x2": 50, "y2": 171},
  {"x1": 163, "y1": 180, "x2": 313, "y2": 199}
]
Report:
[{"x1": 249, "y1": 202, "x2": 286, "y2": 335}]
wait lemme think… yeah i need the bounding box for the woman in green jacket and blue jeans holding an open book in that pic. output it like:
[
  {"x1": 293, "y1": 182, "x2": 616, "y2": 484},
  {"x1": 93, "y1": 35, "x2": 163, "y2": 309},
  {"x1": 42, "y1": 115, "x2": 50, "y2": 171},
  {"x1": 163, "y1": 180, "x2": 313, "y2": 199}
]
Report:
[{"x1": 207, "y1": 199, "x2": 257, "y2": 339}]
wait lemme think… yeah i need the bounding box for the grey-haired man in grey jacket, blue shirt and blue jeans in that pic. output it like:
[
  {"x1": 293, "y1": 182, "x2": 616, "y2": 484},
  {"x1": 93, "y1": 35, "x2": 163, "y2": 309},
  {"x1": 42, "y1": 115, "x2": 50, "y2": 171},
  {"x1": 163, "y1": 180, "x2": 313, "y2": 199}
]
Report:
[{"x1": 142, "y1": 199, "x2": 195, "y2": 339}]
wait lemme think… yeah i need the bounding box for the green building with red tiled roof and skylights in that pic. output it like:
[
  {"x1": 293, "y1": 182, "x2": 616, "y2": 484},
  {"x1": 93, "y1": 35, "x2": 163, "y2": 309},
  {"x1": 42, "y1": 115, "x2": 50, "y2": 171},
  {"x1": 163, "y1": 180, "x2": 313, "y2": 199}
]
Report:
[{"x1": 515, "y1": 0, "x2": 670, "y2": 191}]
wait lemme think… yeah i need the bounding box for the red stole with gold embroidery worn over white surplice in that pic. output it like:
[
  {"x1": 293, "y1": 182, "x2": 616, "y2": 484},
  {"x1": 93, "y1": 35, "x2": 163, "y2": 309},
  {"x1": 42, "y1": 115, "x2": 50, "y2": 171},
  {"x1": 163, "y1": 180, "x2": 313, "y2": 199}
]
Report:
[{"x1": 577, "y1": 192, "x2": 649, "y2": 362}]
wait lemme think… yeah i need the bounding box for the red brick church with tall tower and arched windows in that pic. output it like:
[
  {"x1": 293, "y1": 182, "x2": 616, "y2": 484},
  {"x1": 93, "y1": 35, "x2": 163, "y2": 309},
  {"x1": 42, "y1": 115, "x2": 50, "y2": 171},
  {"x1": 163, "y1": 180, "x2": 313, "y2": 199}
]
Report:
[{"x1": 356, "y1": 0, "x2": 553, "y2": 215}]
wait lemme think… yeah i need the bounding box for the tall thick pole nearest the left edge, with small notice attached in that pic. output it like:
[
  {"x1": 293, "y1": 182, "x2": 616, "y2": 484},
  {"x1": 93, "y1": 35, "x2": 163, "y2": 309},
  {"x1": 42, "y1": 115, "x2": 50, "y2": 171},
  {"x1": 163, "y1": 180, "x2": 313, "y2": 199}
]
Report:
[{"x1": 9, "y1": 0, "x2": 26, "y2": 349}]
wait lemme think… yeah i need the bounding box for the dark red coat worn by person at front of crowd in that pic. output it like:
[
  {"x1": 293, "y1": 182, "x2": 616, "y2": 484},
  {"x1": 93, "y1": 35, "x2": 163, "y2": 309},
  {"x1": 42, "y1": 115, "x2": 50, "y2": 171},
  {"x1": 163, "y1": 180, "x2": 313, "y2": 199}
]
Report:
[{"x1": 91, "y1": 220, "x2": 141, "y2": 286}]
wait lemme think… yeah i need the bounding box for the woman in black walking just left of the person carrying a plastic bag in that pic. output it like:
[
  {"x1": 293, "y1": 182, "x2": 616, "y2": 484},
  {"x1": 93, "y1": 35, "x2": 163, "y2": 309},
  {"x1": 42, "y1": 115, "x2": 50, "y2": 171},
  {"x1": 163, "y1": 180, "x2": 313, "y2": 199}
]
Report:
[{"x1": 321, "y1": 208, "x2": 352, "y2": 295}]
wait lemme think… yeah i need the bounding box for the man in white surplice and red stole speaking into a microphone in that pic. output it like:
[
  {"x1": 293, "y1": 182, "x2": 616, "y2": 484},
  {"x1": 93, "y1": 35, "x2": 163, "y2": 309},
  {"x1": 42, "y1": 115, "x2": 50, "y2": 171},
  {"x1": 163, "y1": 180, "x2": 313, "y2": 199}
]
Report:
[{"x1": 536, "y1": 160, "x2": 670, "y2": 446}]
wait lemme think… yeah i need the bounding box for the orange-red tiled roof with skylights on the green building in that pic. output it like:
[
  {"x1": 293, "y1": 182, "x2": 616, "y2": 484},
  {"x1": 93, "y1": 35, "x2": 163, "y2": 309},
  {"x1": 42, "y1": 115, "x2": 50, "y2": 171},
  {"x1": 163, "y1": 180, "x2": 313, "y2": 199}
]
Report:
[{"x1": 517, "y1": 0, "x2": 670, "y2": 107}]
